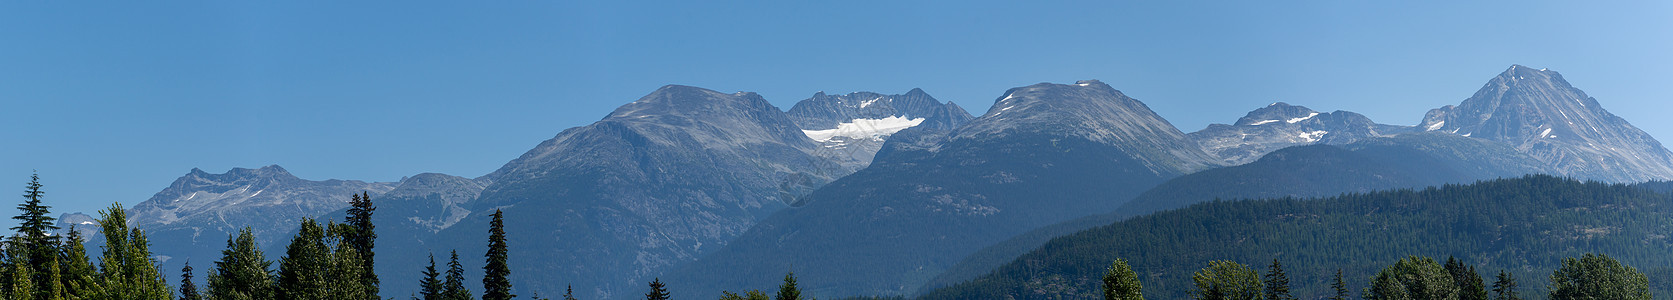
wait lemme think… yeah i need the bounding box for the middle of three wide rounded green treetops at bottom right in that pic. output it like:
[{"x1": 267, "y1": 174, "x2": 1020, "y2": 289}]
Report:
[{"x1": 1365, "y1": 256, "x2": 1459, "y2": 300}]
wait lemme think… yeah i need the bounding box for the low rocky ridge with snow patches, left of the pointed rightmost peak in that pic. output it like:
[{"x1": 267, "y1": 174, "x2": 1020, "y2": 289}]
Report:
[{"x1": 1188, "y1": 102, "x2": 1412, "y2": 166}]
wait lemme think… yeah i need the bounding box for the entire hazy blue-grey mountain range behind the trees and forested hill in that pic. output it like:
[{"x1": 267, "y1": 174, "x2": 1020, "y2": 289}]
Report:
[{"x1": 97, "y1": 65, "x2": 1673, "y2": 298}]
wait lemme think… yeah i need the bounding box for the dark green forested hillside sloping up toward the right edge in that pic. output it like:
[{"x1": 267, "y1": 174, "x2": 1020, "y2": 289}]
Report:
[{"x1": 925, "y1": 176, "x2": 1673, "y2": 298}]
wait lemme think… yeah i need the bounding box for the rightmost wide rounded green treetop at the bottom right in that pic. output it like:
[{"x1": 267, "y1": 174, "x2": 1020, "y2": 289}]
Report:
[{"x1": 1549, "y1": 253, "x2": 1650, "y2": 300}]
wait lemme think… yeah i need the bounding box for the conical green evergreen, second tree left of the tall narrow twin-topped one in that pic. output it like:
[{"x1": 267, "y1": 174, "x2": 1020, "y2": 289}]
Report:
[{"x1": 209, "y1": 228, "x2": 274, "y2": 300}]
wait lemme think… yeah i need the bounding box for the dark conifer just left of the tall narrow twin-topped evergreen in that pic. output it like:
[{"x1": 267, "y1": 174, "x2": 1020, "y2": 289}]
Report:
[{"x1": 276, "y1": 218, "x2": 331, "y2": 298}]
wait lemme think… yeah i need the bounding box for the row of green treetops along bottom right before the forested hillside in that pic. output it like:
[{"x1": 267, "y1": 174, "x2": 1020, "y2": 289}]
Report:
[{"x1": 1101, "y1": 253, "x2": 1651, "y2": 300}]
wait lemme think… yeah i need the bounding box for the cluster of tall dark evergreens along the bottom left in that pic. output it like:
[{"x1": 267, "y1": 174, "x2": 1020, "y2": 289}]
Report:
[{"x1": 0, "y1": 174, "x2": 521, "y2": 300}]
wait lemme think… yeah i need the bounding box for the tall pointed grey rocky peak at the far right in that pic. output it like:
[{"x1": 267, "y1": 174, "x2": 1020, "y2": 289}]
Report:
[{"x1": 1417, "y1": 65, "x2": 1673, "y2": 183}]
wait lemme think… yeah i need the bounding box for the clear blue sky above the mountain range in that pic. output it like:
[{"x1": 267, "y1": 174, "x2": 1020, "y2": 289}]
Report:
[{"x1": 0, "y1": 0, "x2": 1673, "y2": 213}]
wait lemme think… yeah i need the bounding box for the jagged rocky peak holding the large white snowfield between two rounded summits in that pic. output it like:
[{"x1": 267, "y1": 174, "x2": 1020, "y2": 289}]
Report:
[{"x1": 786, "y1": 89, "x2": 974, "y2": 171}]
